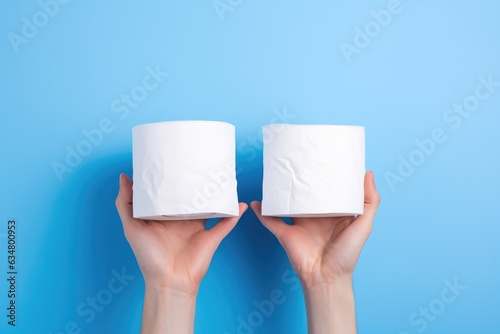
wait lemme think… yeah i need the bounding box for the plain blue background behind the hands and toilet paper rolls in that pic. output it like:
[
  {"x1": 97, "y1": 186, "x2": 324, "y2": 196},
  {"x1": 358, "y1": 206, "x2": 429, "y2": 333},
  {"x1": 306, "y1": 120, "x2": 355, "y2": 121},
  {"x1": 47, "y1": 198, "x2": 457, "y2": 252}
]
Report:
[{"x1": 0, "y1": 0, "x2": 500, "y2": 334}]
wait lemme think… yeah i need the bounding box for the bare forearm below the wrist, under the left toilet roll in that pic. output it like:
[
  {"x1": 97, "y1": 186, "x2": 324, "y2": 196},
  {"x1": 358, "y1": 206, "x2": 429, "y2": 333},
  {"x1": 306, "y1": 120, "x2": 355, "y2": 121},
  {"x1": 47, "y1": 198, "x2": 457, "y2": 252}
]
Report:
[{"x1": 141, "y1": 285, "x2": 196, "y2": 334}]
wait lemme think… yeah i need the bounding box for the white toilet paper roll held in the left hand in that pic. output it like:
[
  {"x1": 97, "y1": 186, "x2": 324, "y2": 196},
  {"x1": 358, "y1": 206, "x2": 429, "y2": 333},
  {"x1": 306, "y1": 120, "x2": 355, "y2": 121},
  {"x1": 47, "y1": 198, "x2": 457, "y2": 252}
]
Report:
[{"x1": 132, "y1": 121, "x2": 239, "y2": 220}]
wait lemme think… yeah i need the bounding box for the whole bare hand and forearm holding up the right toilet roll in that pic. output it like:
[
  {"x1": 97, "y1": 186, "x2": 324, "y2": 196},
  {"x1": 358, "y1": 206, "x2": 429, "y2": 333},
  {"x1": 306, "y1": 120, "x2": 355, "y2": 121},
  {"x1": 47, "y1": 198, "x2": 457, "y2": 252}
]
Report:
[{"x1": 251, "y1": 172, "x2": 380, "y2": 334}]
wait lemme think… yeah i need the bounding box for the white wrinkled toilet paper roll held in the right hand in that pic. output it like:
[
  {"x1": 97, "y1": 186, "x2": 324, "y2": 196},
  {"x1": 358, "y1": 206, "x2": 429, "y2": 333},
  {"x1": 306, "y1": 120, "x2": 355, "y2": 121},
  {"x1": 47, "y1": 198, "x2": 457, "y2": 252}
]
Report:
[{"x1": 262, "y1": 124, "x2": 365, "y2": 217}]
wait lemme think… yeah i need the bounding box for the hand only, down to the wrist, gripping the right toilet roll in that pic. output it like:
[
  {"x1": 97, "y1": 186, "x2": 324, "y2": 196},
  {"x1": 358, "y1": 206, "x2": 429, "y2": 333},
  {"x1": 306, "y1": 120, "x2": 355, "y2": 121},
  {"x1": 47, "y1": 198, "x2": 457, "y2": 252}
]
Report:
[{"x1": 251, "y1": 172, "x2": 380, "y2": 288}]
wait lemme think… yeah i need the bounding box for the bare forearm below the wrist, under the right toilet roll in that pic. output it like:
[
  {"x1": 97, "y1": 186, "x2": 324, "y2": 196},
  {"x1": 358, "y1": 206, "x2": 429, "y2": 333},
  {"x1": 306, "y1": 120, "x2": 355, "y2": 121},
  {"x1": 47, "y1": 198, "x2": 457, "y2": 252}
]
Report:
[{"x1": 304, "y1": 280, "x2": 356, "y2": 334}]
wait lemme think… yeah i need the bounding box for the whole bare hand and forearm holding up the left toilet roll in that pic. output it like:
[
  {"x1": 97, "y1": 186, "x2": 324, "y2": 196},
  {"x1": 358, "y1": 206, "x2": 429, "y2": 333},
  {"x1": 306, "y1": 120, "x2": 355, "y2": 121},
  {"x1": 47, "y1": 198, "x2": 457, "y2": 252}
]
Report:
[{"x1": 116, "y1": 174, "x2": 248, "y2": 334}]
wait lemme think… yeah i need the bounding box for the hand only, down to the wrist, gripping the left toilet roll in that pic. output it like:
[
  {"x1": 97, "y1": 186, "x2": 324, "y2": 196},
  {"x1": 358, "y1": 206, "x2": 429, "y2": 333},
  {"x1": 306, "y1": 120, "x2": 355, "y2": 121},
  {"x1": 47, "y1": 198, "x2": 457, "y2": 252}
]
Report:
[{"x1": 116, "y1": 174, "x2": 248, "y2": 295}]
